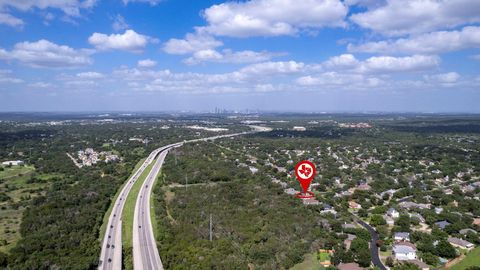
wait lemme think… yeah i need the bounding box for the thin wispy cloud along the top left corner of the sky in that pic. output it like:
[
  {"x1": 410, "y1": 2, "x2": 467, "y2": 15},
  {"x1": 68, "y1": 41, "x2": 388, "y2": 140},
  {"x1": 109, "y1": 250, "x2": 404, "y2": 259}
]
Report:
[{"x1": 0, "y1": 0, "x2": 97, "y2": 17}]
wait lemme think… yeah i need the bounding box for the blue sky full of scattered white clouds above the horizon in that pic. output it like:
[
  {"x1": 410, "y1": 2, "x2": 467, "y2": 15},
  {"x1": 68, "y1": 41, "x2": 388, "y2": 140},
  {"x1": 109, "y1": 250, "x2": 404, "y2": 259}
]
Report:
[{"x1": 0, "y1": 0, "x2": 480, "y2": 112}]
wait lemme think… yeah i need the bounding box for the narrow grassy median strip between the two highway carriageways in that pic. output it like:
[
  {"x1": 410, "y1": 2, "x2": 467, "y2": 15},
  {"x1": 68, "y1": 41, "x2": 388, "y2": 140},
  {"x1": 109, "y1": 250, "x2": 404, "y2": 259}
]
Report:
[{"x1": 122, "y1": 161, "x2": 155, "y2": 269}]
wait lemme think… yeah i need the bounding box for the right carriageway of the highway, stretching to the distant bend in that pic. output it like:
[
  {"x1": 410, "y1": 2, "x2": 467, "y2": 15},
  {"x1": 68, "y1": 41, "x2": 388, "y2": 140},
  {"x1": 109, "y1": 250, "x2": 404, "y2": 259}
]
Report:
[{"x1": 133, "y1": 126, "x2": 271, "y2": 270}]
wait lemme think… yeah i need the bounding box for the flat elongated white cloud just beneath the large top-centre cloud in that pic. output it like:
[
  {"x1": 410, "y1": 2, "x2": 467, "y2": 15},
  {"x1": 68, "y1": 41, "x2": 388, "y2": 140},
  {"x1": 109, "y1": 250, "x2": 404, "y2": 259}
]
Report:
[{"x1": 185, "y1": 49, "x2": 283, "y2": 65}]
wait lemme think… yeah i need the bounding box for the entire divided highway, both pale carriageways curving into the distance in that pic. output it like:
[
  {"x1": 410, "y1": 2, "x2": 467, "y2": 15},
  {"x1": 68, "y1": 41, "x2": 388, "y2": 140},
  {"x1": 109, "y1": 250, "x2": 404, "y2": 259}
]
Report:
[{"x1": 98, "y1": 126, "x2": 271, "y2": 270}]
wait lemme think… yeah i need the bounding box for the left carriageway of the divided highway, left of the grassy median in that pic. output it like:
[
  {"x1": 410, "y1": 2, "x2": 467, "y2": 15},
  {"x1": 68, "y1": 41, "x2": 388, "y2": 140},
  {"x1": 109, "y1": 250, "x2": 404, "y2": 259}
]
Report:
[{"x1": 98, "y1": 147, "x2": 172, "y2": 270}]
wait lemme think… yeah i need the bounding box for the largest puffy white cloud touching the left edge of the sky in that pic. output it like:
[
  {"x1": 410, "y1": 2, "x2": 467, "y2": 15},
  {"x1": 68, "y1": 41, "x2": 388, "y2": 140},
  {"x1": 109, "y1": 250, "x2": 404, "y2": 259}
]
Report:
[{"x1": 0, "y1": 39, "x2": 93, "y2": 68}]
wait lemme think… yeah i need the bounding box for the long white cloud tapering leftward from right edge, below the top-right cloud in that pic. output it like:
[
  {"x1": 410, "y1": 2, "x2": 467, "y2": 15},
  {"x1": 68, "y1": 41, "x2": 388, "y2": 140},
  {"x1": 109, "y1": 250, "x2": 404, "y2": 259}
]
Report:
[{"x1": 348, "y1": 26, "x2": 480, "y2": 54}]
